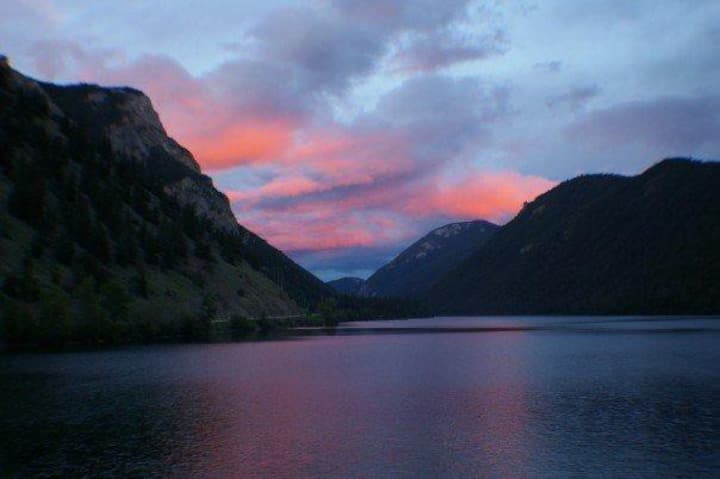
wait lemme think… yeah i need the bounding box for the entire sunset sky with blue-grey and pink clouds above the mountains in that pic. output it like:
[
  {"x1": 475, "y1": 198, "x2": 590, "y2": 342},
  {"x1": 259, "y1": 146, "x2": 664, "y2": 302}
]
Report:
[{"x1": 0, "y1": 0, "x2": 720, "y2": 279}]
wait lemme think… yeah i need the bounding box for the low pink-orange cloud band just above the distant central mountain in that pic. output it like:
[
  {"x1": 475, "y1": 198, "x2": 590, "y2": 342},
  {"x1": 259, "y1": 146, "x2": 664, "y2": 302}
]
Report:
[{"x1": 230, "y1": 168, "x2": 554, "y2": 251}]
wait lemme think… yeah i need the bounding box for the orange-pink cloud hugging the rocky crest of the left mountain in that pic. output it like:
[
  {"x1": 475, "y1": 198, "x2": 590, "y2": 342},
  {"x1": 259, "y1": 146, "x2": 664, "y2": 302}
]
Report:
[{"x1": 59, "y1": 52, "x2": 301, "y2": 170}]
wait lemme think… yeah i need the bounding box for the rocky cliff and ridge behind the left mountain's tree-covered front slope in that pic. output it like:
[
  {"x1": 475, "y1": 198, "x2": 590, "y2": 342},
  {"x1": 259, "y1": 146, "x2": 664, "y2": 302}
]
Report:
[{"x1": 40, "y1": 69, "x2": 332, "y2": 306}]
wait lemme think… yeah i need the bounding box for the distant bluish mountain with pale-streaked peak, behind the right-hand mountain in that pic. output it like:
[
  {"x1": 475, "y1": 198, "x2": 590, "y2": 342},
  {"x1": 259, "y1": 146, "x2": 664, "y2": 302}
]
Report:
[{"x1": 358, "y1": 220, "x2": 498, "y2": 298}]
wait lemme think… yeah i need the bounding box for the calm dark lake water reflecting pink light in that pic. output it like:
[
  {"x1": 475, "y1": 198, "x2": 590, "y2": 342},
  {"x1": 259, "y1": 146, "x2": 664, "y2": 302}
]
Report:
[{"x1": 0, "y1": 317, "x2": 720, "y2": 478}]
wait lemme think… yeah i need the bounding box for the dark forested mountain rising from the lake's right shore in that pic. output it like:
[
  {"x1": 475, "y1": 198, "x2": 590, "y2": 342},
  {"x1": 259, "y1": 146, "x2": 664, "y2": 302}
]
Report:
[{"x1": 428, "y1": 159, "x2": 720, "y2": 314}]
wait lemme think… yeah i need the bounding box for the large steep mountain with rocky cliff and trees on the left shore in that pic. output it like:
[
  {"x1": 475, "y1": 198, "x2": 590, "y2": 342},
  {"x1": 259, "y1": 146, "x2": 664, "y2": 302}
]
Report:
[{"x1": 0, "y1": 57, "x2": 334, "y2": 342}]
